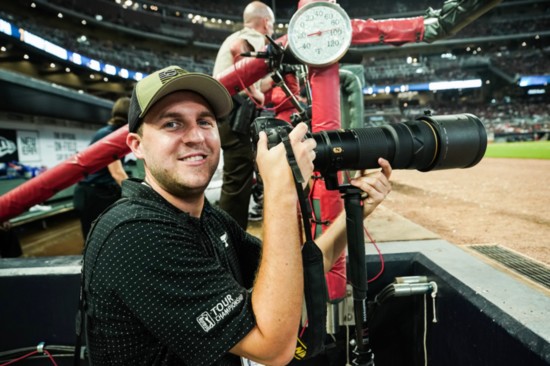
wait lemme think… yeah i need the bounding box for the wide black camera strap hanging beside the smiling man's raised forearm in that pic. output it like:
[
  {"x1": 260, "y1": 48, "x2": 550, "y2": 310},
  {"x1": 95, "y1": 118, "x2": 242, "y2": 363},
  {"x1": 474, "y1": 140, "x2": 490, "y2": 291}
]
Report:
[{"x1": 279, "y1": 128, "x2": 328, "y2": 364}]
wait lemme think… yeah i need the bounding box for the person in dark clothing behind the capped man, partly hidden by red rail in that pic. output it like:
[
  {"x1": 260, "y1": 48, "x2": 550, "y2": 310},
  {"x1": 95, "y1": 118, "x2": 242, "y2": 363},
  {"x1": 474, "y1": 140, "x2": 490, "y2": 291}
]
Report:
[{"x1": 73, "y1": 97, "x2": 130, "y2": 240}]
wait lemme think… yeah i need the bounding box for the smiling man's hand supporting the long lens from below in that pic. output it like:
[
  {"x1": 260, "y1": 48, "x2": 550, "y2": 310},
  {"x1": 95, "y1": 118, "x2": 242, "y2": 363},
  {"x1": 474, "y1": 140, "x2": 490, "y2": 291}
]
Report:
[{"x1": 350, "y1": 158, "x2": 392, "y2": 217}]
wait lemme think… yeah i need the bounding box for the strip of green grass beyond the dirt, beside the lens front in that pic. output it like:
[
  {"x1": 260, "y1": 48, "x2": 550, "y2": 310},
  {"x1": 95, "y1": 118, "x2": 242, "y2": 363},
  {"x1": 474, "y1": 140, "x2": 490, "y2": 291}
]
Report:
[{"x1": 485, "y1": 141, "x2": 550, "y2": 159}]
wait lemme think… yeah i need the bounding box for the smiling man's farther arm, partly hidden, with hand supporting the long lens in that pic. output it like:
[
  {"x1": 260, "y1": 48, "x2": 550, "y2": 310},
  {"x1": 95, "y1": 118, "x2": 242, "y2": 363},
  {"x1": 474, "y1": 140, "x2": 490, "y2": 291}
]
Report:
[{"x1": 315, "y1": 158, "x2": 392, "y2": 272}]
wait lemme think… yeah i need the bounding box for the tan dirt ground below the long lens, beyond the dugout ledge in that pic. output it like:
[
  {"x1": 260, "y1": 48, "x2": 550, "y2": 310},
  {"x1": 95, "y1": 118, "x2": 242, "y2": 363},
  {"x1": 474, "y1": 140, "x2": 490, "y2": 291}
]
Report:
[{"x1": 383, "y1": 158, "x2": 550, "y2": 265}]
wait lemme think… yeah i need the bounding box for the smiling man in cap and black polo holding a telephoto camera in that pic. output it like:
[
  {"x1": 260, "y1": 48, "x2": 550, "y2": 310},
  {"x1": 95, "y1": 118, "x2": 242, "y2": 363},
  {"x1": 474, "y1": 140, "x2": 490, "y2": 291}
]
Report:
[{"x1": 84, "y1": 66, "x2": 391, "y2": 366}]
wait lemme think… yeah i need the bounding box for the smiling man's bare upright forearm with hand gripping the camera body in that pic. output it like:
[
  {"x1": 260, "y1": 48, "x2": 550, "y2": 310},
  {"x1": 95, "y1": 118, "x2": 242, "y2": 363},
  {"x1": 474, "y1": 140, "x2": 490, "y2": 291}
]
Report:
[{"x1": 231, "y1": 123, "x2": 316, "y2": 365}]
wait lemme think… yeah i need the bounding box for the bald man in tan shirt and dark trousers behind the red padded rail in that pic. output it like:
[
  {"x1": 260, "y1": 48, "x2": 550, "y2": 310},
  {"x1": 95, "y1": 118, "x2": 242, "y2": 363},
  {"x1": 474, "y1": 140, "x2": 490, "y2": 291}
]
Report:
[{"x1": 213, "y1": 1, "x2": 275, "y2": 229}]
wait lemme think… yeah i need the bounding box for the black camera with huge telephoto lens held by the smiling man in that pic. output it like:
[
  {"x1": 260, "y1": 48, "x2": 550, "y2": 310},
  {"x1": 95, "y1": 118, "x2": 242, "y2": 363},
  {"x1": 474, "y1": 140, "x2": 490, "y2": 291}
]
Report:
[{"x1": 251, "y1": 112, "x2": 487, "y2": 189}]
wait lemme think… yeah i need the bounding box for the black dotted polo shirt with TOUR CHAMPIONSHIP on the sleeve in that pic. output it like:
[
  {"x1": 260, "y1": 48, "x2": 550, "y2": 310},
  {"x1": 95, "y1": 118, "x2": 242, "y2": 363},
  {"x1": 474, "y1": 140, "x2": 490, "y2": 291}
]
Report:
[{"x1": 84, "y1": 180, "x2": 260, "y2": 366}]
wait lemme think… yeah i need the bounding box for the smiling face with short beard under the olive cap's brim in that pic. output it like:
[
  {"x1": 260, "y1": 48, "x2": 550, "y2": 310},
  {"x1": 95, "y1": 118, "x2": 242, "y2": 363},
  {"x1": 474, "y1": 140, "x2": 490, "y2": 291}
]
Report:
[{"x1": 129, "y1": 91, "x2": 220, "y2": 198}]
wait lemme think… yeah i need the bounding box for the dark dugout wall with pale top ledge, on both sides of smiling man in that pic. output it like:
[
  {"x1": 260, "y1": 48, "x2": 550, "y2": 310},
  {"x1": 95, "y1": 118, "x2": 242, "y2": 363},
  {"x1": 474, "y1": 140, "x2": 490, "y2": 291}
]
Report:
[{"x1": 0, "y1": 240, "x2": 550, "y2": 366}]
